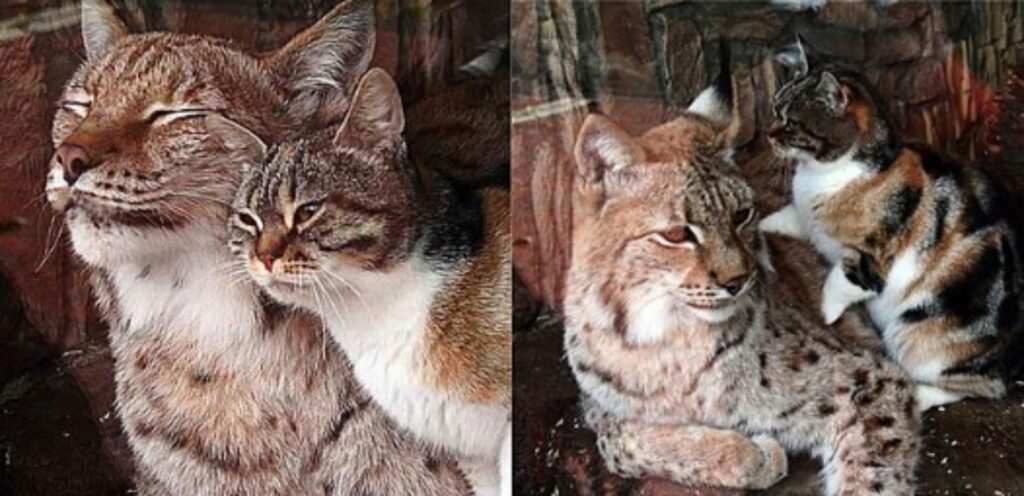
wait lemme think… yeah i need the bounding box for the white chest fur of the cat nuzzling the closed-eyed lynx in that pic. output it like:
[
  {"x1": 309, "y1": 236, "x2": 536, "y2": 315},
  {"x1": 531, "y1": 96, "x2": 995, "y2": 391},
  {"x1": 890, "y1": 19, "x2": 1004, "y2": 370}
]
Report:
[{"x1": 326, "y1": 261, "x2": 509, "y2": 464}]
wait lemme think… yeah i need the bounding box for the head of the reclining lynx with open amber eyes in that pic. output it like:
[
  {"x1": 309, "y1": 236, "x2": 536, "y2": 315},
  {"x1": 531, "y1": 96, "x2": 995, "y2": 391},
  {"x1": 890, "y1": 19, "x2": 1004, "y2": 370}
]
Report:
[{"x1": 567, "y1": 111, "x2": 763, "y2": 342}]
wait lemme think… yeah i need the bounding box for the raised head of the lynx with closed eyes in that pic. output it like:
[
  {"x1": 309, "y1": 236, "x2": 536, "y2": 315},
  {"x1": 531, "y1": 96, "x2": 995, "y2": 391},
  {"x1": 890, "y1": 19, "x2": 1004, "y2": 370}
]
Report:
[{"x1": 46, "y1": 0, "x2": 374, "y2": 266}]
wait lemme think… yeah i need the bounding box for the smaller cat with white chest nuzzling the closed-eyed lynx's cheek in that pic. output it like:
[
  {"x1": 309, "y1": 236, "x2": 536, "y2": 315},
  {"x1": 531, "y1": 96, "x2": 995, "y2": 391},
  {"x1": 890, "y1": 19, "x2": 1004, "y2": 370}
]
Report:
[{"x1": 230, "y1": 69, "x2": 511, "y2": 494}]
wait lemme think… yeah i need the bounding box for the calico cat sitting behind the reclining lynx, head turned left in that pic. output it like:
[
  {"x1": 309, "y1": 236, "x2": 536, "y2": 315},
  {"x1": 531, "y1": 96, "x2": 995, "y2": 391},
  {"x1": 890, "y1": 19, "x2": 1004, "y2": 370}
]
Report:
[{"x1": 762, "y1": 38, "x2": 1022, "y2": 410}]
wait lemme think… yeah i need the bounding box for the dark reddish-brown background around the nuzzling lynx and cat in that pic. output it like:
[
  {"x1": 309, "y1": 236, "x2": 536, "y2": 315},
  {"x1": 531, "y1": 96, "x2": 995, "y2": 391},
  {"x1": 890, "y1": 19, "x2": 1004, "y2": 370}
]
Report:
[{"x1": 0, "y1": 0, "x2": 508, "y2": 495}]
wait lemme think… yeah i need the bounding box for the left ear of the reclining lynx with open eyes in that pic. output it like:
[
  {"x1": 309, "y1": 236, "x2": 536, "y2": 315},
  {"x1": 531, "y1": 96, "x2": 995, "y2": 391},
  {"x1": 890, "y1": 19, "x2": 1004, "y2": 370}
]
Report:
[{"x1": 575, "y1": 114, "x2": 645, "y2": 183}]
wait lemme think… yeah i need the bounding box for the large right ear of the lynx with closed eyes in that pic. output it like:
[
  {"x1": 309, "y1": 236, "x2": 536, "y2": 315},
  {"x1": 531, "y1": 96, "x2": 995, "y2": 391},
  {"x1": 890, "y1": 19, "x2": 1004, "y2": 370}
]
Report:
[{"x1": 269, "y1": 0, "x2": 376, "y2": 124}]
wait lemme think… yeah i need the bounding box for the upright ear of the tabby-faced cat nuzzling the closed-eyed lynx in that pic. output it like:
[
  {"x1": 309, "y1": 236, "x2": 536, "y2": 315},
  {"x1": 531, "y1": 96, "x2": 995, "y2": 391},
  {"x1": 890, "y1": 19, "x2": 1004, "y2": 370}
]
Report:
[{"x1": 335, "y1": 68, "x2": 406, "y2": 143}]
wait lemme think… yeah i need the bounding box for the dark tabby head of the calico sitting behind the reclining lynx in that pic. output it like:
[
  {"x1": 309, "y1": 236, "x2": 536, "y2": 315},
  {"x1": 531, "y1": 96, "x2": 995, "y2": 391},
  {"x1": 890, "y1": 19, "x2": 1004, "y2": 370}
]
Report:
[{"x1": 768, "y1": 39, "x2": 893, "y2": 164}]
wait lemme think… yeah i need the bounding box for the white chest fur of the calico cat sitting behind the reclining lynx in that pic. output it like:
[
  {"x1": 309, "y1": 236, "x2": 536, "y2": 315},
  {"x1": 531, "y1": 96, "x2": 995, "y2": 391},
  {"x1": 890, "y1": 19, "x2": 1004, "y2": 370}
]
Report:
[{"x1": 793, "y1": 151, "x2": 868, "y2": 259}]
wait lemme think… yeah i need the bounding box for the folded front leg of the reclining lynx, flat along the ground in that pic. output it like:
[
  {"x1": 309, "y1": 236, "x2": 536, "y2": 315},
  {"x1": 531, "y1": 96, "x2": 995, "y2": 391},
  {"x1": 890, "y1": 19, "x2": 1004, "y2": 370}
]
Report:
[{"x1": 588, "y1": 405, "x2": 786, "y2": 489}]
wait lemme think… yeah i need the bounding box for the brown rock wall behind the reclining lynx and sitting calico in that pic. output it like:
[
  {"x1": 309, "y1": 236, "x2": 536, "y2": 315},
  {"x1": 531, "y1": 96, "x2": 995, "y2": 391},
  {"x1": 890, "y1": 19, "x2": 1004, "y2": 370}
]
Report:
[{"x1": 512, "y1": 0, "x2": 1024, "y2": 305}]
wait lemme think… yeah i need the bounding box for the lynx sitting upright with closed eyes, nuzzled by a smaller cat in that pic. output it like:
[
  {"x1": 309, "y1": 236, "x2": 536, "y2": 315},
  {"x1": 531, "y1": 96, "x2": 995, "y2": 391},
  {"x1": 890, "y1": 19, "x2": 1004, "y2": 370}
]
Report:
[{"x1": 46, "y1": 0, "x2": 468, "y2": 495}]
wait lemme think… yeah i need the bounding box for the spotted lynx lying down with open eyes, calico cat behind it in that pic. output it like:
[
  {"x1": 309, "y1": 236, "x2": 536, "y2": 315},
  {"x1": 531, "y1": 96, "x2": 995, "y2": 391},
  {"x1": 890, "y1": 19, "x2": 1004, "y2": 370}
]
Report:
[{"x1": 564, "y1": 77, "x2": 920, "y2": 495}]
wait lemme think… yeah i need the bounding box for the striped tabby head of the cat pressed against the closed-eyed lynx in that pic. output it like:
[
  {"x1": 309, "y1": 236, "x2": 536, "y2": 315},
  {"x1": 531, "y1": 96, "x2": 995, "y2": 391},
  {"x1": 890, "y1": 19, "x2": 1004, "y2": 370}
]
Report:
[{"x1": 229, "y1": 69, "x2": 418, "y2": 303}]
